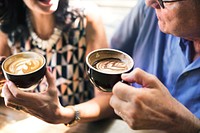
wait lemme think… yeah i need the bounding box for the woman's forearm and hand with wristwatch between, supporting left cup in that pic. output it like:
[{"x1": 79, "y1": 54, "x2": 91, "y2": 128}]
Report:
[{"x1": 2, "y1": 67, "x2": 115, "y2": 124}]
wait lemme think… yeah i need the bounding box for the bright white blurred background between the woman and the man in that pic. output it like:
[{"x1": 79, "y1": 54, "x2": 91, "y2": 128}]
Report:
[{"x1": 71, "y1": 0, "x2": 138, "y2": 41}]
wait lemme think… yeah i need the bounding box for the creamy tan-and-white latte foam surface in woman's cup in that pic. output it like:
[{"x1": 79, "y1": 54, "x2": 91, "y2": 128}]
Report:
[{"x1": 7, "y1": 57, "x2": 42, "y2": 74}]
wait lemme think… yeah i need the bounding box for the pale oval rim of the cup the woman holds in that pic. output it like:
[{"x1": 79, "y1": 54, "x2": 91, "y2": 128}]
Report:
[{"x1": 1, "y1": 51, "x2": 46, "y2": 76}]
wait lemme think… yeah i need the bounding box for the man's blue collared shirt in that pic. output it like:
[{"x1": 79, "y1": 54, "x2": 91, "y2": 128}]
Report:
[{"x1": 111, "y1": 1, "x2": 200, "y2": 118}]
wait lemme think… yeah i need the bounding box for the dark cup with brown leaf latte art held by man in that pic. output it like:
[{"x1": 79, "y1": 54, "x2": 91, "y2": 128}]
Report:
[{"x1": 86, "y1": 48, "x2": 134, "y2": 92}]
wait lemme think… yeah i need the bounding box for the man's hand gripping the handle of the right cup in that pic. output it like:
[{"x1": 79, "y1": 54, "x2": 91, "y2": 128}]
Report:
[{"x1": 110, "y1": 68, "x2": 200, "y2": 133}]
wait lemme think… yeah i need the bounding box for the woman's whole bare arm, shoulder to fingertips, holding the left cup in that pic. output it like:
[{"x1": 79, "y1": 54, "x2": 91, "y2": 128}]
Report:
[{"x1": 3, "y1": 2, "x2": 115, "y2": 124}]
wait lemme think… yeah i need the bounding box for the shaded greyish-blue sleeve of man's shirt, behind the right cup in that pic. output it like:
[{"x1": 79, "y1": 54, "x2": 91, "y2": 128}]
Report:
[{"x1": 110, "y1": 0, "x2": 146, "y2": 55}]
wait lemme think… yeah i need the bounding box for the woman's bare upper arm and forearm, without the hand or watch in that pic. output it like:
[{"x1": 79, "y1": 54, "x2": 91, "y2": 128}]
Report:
[{"x1": 76, "y1": 3, "x2": 116, "y2": 122}]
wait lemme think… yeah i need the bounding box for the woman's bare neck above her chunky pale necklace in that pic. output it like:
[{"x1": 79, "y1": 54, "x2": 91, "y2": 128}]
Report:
[{"x1": 29, "y1": 12, "x2": 55, "y2": 40}]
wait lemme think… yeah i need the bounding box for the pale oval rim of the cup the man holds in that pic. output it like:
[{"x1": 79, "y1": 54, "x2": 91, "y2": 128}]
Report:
[{"x1": 86, "y1": 48, "x2": 134, "y2": 75}]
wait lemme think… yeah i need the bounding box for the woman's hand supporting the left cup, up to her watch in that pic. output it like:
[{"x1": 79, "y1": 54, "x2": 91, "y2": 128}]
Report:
[{"x1": 2, "y1": 69, "x2": 74, "y2": 124}]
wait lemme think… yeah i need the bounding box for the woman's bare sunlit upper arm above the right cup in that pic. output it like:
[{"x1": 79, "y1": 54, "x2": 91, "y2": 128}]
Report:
[{"x1": 85, "y1": 3, "x2": 108, "y2": 54}]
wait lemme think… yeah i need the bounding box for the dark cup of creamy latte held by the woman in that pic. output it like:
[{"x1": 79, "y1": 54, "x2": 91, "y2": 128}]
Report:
[{"x1": 2, "y1": 52, "x2": 46, "y2": 92}]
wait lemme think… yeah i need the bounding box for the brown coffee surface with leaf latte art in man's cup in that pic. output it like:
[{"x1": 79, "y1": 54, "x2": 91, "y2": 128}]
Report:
[{"x1": 93, "y1": 58, "x2": 128, "y2": 74}]
